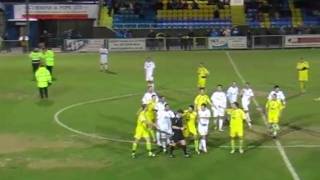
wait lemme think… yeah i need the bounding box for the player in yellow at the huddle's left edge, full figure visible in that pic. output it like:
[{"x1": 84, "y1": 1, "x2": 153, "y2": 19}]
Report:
[{"x1": 131, "y1": 105, "x2": 155, "y2": 158}]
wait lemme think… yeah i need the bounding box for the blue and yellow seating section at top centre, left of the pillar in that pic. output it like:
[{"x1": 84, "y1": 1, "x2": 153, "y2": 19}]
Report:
[{"x1": 113, "y1": 0, "x2": 232, "y2": 29}]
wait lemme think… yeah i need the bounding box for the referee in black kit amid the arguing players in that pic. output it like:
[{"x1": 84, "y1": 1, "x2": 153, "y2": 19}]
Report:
[{"x1": 169, "y1": 109, "x2": 190, "y2": 158}]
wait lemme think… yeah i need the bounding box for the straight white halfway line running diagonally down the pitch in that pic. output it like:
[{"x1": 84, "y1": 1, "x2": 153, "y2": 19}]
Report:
[{"x1": 226, "y1": 51, "x2": 300, "y2": 180}]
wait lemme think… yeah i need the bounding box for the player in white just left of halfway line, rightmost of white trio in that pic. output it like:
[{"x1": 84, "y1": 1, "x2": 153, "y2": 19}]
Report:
[{"x1": 241, "y1": 82, "x2": 254, "y2": 128}]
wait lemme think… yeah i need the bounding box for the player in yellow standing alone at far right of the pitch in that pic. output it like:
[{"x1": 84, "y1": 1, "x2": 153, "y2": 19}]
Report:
[{"x1": 297, "y1": 58, "x2": 310, "y2": 93}]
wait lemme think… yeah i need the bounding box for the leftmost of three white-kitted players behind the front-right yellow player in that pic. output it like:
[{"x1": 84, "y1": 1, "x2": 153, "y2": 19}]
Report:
[{"x1": 211, "y1": 84, "x2": 227, "y2": 131}]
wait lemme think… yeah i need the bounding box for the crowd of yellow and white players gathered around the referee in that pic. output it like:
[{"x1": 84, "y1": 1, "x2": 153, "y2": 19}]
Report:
[{"x1": 132, "y1": 61, "x2": 285, "y2": 158}]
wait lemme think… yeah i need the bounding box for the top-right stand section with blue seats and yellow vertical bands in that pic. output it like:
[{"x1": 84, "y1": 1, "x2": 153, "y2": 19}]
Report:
[{"x1": 245, "y1": 0, "x2": 320, "y2": 28}]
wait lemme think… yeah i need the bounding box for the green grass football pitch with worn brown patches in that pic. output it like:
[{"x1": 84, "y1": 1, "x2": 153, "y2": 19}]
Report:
[{"x1": 0, "y1": 49, "x2": 320, "y2": 180}]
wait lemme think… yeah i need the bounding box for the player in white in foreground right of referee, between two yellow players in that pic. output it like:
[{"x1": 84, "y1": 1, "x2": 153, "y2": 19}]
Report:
[{"x1": 198, "y1": 104, "x2": 211, "y2": 153}]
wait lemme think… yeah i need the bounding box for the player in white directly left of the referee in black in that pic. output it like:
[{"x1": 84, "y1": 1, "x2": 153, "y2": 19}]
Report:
[{"x1": 156, "y1": 104, "x2": 175, "y2": 152}]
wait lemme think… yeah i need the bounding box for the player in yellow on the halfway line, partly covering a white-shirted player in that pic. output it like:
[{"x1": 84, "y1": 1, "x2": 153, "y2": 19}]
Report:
[{"x1": 266, "y1": 94, "x2": 284, "y2": 138}]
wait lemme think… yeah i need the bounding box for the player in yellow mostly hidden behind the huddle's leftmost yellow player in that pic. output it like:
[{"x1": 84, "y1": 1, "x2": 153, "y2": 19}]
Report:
[{"x1": 146, "y1": 94, "x2": 157, "y2": 142}]
